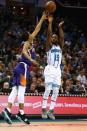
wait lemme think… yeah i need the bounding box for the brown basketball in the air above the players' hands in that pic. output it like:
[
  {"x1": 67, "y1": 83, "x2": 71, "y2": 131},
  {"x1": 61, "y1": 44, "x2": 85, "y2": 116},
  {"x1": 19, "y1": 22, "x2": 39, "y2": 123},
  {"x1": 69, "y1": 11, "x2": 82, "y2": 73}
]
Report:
[{"x1": 45, "y1": 1, "x2": 56, "y2": 13}]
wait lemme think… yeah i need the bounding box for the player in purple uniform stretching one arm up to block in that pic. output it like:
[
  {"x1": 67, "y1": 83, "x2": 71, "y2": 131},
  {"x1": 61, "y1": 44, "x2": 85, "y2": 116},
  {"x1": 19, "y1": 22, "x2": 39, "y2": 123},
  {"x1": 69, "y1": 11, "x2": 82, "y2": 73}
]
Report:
[{"x1": 2, "y1": 13, "x2": 46, "y2": 124}]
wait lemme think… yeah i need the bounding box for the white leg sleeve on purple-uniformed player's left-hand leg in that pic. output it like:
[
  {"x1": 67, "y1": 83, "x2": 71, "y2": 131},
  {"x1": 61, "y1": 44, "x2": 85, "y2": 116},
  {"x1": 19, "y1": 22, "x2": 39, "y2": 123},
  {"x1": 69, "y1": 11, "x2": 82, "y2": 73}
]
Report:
[{"x1": 8, "y1": 86, "x2": 18, "y2": 104}]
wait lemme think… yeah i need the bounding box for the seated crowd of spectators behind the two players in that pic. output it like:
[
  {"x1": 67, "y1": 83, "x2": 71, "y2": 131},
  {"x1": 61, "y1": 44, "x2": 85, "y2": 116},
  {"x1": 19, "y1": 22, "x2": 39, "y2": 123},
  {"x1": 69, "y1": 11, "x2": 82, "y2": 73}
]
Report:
[{"x1": 0, "y1": 5, "x2": 87, "y2": 95}]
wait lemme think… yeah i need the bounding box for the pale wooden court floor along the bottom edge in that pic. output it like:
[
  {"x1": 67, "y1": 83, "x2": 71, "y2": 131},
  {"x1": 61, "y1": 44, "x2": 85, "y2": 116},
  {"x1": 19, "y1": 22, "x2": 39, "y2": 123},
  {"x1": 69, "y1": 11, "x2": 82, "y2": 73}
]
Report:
[{"x1": 0, "y1": 119, "x2": 87, "y2": 131}]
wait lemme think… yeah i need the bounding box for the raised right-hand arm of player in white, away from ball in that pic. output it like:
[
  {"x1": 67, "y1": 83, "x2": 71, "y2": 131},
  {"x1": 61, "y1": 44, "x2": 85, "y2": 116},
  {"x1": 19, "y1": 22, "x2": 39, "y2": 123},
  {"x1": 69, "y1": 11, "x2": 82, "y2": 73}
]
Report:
[{"x1": 59, "y1": 21, "x2": 64, "y2": 49}]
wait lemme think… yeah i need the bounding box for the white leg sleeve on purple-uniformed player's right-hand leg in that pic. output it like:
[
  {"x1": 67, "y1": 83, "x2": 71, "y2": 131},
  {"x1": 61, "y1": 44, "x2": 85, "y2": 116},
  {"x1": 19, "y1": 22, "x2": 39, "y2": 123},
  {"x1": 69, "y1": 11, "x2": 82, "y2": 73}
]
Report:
[{"x1": 18, "y1": 86, "x2": 26, "y2": 103}]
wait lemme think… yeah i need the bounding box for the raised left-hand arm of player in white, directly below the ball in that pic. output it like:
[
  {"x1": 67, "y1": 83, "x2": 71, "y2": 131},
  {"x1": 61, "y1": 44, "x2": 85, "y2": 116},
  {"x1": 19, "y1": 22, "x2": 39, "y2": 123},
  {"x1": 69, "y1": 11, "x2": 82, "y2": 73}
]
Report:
[{"x1": 46, "y1": 16, "x2": 53, "y2": 51}]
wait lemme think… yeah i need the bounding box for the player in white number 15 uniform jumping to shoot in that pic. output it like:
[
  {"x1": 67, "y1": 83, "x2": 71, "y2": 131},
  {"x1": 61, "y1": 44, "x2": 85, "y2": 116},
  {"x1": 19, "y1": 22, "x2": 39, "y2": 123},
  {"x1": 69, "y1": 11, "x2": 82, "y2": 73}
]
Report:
[{"x1": 42, "y1": 16, "x2": 64, "y2": 120}]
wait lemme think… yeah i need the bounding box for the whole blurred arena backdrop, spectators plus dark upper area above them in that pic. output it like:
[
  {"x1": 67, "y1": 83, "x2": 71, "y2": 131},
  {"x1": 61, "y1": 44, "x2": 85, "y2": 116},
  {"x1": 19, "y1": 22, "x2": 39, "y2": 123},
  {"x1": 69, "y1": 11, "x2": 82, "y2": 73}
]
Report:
[{"x1": 0, "y1": 0, "x2": 87, "y2": 96}]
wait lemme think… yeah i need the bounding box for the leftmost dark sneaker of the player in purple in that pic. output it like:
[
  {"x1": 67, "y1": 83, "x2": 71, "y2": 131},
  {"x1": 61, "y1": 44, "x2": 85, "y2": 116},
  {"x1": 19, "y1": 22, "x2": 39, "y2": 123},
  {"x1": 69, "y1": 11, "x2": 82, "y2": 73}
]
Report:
[{"x1": 2, "y1": 108, "x2": 12, "y2": 124}]
